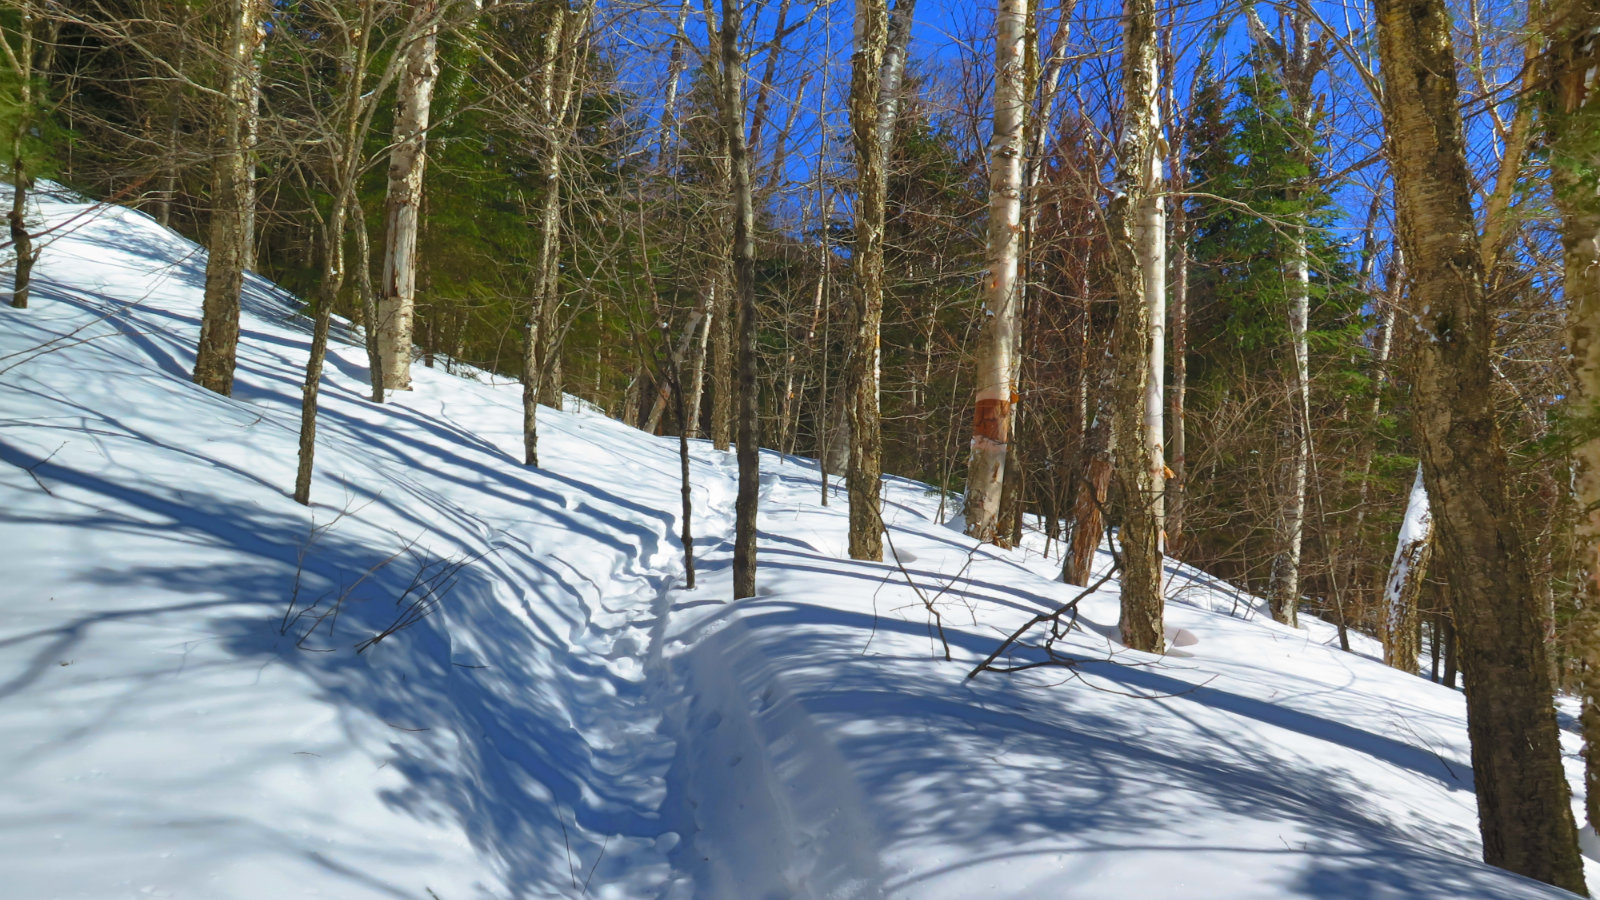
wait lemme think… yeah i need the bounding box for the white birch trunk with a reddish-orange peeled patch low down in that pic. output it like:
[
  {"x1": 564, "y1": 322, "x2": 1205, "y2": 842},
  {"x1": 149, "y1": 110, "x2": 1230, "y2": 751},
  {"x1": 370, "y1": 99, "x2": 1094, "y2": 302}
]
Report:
[{"x1": 965, "y1": 0, "x2": 1029, "y2": 541}]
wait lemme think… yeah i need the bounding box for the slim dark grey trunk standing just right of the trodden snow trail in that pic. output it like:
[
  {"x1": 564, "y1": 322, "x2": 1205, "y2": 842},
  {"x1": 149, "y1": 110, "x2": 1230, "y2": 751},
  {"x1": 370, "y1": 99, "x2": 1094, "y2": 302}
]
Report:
[{"x1": 722, "y1": 0, "x2": 762, "y2": 601}]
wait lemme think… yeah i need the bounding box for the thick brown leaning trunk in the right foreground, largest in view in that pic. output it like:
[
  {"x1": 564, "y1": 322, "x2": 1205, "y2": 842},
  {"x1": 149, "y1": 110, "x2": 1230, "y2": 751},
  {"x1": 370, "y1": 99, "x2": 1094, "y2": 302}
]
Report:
[{"x1": 1374, "y1": 0, "x2": 1586, "y2": 894}]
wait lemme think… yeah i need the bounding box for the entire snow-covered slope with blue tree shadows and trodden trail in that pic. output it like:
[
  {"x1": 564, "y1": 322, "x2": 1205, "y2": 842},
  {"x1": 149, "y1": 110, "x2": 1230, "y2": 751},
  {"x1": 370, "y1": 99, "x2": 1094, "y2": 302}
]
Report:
[{"x1": 0, "y1": 185, "x2": 1600, "y2": 900}]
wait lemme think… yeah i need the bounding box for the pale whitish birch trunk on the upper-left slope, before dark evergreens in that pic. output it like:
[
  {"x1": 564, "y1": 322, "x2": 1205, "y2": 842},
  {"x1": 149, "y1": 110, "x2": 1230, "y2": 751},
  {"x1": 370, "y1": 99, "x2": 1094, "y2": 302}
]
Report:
[{"x1": 378, "y1": 0, "x2": 440, "y2": 391}]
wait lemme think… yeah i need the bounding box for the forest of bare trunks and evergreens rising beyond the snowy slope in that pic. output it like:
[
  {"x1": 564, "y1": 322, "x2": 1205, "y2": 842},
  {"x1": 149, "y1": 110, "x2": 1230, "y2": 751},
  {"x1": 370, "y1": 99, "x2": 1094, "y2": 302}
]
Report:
[{"x1": 9, "y1": 0, "x2": 1600, "y2": 894}]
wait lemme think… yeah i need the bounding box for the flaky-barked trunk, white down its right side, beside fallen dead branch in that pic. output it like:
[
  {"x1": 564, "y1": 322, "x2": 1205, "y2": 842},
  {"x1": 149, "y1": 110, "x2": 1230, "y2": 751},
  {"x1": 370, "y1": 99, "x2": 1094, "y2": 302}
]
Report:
[{"x1": 1106, "y1": 0, "x2": 1165, "y2": 653}]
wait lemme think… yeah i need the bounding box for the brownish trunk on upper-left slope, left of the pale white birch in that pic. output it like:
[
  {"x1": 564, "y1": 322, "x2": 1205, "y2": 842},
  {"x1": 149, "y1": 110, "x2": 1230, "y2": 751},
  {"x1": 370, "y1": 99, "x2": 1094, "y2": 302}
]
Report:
[{"x1": 194, "y1": 0, "x2": 261, "y2": 396}]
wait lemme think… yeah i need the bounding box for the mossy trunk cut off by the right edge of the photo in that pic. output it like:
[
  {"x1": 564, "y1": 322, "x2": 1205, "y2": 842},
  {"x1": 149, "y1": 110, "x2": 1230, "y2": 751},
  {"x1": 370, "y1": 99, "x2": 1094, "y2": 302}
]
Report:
[{"x1": 1546, "y1": 0, "x2": 1600, "y2": 826}]
